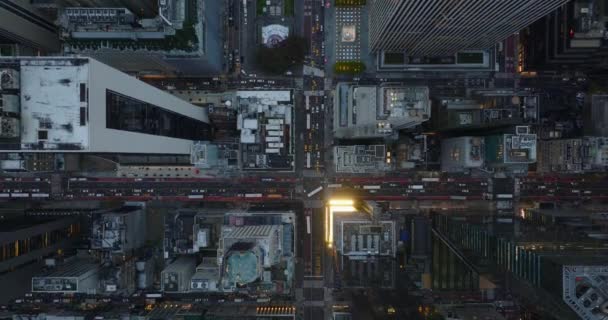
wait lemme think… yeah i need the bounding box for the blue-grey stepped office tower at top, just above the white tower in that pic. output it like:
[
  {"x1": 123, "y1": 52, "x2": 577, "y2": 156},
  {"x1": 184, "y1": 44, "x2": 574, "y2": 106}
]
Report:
[{"x1": 58, "y1": 0, "x2": 223, "y2": 76}]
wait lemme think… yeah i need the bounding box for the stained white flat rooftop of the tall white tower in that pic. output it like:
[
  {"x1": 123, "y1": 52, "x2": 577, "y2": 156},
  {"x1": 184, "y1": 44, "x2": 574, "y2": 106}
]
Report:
[{"x1": 21, "y1": 60, "x2": 89, "y2": 150}]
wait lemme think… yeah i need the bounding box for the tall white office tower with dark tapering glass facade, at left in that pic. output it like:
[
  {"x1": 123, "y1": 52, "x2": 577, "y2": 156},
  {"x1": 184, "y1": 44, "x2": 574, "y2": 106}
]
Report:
[{"x1": 0, "y1": 57, "x2": 211, "y2": 155}]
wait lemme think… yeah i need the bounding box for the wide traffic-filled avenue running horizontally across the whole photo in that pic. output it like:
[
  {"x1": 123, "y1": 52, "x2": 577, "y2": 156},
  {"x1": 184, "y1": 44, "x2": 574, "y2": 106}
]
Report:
[{"x1": 0, "y1": 174, "x2": 608, "y2": 201}]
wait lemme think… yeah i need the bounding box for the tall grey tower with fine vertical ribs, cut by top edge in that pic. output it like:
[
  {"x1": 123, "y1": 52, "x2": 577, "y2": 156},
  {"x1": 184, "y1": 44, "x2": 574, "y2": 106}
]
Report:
[{"x1": 369, "y1": 0, "x2": 568, "y2": 57}]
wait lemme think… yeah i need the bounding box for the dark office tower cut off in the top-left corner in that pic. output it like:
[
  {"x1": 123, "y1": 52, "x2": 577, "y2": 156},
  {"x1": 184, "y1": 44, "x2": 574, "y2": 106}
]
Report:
[{"x1": 0, "y1": 0, "x2": 60, "y2": 56}]
